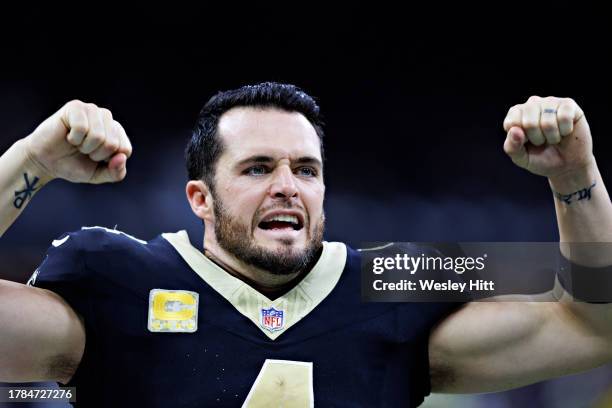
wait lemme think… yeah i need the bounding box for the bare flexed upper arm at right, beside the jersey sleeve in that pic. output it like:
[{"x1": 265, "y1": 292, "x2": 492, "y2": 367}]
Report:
[{"x1": 429, "y1": 302, "x2": 612, "y2": 392}]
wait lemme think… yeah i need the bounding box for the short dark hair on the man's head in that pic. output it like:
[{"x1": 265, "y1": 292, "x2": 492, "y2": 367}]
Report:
[{"x1": 185, "y1": 82, "x2": 323, "y2": 190}]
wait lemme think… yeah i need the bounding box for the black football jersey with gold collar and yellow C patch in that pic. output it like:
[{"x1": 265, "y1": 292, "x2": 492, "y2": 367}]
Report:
[{"x1": 30, "y1": 227, "x2": 457, "y2": 408}]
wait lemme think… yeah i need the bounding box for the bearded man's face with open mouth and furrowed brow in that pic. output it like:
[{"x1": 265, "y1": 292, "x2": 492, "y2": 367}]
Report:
[{"x1": 209, "y1": 108, "x2": 325, "y2": 274}]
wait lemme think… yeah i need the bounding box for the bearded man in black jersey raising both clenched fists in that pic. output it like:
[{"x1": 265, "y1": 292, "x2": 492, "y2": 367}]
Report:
[{"x1": 0, "y1": 83, "x2": 612, "y2": 407}]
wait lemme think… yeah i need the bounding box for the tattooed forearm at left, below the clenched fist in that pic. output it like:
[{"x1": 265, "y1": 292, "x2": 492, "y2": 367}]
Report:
[{"x1": 0, "y1": 139, "x2": 50, "y2": 237}]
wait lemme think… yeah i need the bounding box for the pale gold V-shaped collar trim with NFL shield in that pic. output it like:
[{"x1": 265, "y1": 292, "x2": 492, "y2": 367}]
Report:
[{"x1": 162, "y1": 231, "x2": 346, "y2": 340}]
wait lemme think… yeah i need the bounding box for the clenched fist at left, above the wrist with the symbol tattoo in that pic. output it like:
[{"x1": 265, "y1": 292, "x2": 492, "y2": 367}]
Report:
[{"x1": 25, "y1": 100, "x2": 132, "y2": 184}]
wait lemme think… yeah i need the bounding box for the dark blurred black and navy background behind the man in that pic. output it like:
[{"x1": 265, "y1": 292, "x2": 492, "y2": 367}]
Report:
[{"x1": 0, "y1": 2, "x2": 612, "y2": 408}]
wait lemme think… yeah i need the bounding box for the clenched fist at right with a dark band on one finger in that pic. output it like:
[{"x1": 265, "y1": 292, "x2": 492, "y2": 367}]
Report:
[{"x1": 504, "y1": 96, "x2": 594, "y2": 178}]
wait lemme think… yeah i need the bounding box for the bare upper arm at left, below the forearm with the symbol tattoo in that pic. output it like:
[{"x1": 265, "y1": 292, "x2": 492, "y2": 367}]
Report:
[{"x1": 0, "y1": 280, "x2": 85, "y2": 383}]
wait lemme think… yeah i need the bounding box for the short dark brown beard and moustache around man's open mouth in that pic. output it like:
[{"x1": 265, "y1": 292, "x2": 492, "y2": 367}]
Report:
[{"x1": 213, "y1": 197, "x2": 325, "y2": 275}]
